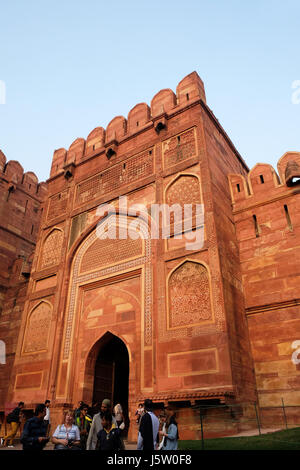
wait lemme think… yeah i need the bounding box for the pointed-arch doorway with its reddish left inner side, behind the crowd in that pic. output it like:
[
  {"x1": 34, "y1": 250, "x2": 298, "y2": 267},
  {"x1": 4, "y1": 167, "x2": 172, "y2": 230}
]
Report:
[{"x1": 85, "y1": 332, "x2": 129, "y2": 414}]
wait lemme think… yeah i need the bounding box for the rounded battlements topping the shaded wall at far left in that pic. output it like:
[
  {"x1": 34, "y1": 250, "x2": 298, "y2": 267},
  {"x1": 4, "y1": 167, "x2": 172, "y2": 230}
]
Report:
[{"x1": 0, "y1": 150, "x2": 47, "y2": 199}]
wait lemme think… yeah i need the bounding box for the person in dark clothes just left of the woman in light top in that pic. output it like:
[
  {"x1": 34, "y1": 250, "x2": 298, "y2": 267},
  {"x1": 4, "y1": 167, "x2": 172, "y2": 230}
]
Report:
[{"x1": 21, "y1": 403, "x2": 49, "y2": 450}]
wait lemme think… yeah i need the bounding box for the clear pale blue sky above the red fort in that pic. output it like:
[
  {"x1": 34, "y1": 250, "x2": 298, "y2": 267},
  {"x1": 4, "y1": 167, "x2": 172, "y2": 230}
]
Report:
[{"x1": 0, "y1": 0, "x2": 300, "y2": 180}]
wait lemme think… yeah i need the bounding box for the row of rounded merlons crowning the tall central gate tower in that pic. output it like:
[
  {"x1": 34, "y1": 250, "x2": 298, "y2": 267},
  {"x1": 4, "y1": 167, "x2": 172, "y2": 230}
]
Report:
[{"x1": 50, "y1": 72, "x2": 205, "y2": 178}]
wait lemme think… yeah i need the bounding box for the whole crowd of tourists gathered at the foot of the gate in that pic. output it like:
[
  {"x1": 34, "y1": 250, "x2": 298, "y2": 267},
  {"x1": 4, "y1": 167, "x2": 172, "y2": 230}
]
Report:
[{"x1": 1, "y1": 399, "x2": 178, "y2": 451}]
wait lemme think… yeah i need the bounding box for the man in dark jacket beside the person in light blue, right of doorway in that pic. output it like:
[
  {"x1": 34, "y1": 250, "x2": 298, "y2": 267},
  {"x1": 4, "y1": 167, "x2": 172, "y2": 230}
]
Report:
[{"x1": 137, "y1": 398, "x2": 159, "y2": 450}]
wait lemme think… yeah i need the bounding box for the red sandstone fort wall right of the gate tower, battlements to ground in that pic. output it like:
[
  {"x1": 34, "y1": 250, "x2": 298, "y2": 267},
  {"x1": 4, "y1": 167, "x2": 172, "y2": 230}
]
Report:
[{"x1": 229, "y1": 152, "x2": 300, "y2": 419}]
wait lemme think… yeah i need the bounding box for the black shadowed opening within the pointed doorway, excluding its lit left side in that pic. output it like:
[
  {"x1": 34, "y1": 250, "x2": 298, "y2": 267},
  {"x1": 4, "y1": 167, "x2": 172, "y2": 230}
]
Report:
[{"x1": 93, "y1": 334, "x2": 129, "y2": 416}]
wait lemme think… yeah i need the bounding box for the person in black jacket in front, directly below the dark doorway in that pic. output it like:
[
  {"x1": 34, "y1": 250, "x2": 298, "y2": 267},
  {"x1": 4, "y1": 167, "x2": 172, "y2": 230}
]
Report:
[{"x1": 96, "y1": 411, "x2": 124, "y2": 452}]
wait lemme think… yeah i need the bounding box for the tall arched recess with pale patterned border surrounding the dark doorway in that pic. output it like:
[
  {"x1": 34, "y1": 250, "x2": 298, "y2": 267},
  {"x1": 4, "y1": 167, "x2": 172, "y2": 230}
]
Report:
[{"x1": 56, "y1": 214, "x2": 153, "y2": 406}]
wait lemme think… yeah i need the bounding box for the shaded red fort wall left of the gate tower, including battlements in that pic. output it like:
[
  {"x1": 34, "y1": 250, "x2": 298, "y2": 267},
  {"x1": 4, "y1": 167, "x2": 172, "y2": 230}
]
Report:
[{"x1": 0, "y1": 151, "x2": 47, "y2": 409}]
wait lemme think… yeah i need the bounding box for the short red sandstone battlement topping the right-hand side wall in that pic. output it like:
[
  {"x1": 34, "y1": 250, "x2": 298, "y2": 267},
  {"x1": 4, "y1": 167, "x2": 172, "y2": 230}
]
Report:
[{"x1": 228, "y1": 152, "x2": 300, "y2": 206}]
